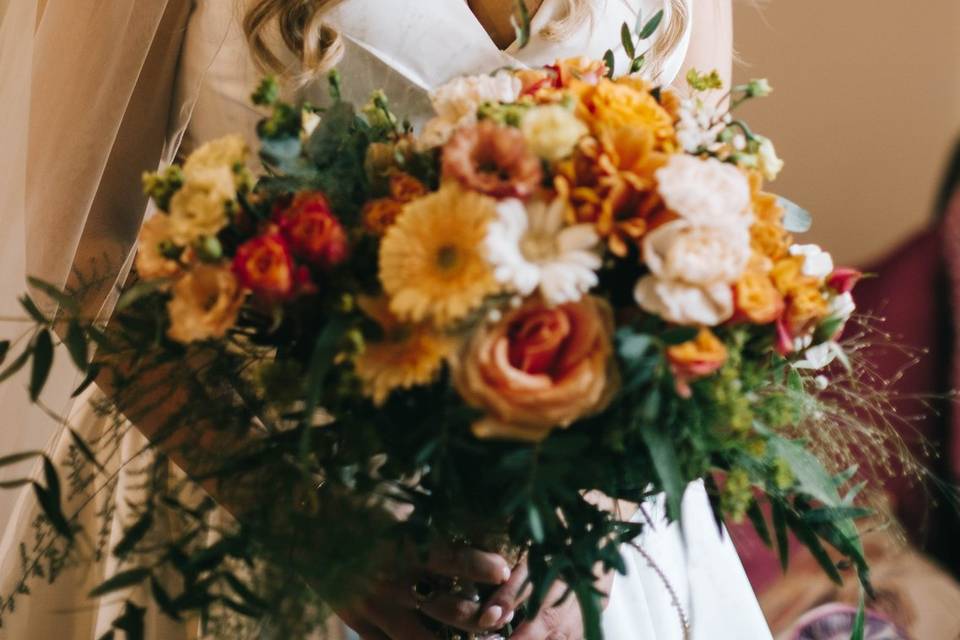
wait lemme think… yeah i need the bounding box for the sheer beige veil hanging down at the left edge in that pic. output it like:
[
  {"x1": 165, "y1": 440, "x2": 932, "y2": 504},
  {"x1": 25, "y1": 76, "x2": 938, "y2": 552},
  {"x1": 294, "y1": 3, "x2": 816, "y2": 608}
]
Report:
[{"x1": 0, "y1": 0, "x2": 201, "y2": 532}]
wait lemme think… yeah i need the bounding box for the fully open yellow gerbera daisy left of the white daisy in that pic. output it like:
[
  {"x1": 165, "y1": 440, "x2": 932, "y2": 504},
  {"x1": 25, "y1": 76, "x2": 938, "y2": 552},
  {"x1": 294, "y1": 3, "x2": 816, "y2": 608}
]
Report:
[{"x1": 380, "y1": 184, "x2": 499, "y2": 327}]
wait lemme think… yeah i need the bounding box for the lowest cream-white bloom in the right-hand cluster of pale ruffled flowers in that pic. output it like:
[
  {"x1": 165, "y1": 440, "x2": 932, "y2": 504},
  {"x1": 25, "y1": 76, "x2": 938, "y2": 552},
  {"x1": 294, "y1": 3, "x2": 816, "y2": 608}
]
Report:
[{"x1": 633, "y1": 275, "x2": 733, "y2": 327}]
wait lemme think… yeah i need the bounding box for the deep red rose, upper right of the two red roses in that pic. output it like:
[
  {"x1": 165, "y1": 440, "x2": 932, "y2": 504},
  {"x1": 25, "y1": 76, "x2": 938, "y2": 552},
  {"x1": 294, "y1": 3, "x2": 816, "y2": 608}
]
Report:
[{"x1": 280, "y1": 191, "x2": 347, "y2": 268}]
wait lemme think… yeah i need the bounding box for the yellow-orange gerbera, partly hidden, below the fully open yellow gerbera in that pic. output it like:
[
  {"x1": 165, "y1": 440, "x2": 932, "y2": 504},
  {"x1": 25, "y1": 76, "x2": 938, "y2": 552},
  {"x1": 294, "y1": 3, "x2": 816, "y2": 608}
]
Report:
[{"x1": 354, "y1": 297, "x2": 455, "y2": 405}]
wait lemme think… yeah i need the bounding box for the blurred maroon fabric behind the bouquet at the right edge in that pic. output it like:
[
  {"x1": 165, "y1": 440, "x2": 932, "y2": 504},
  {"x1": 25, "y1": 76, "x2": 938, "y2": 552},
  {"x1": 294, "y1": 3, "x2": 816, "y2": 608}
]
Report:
[{"x1": 731, "y1": 221, "x2": 960, "y2": 592}]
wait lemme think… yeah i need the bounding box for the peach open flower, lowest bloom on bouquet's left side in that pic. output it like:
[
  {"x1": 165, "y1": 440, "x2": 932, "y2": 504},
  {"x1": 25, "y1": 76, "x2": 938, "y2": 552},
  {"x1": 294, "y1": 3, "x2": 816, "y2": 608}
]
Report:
[{"x1": 167, "y1": 264, "x2": 243, "y2": 344}]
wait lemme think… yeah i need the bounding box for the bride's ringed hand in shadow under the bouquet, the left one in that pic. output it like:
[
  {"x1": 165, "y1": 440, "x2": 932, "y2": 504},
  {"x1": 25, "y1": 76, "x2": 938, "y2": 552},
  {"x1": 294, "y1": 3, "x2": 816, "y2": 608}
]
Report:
[{"x1": 336, "y1": 548, "x2": 511, "y2": 640}]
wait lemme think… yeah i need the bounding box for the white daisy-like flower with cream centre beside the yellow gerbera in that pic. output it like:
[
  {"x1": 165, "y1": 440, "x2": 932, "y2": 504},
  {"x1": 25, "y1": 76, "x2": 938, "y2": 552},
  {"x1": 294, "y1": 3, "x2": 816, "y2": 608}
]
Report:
[{"x1": 486, "y1": 199, "x2": 602, "y2": 305}]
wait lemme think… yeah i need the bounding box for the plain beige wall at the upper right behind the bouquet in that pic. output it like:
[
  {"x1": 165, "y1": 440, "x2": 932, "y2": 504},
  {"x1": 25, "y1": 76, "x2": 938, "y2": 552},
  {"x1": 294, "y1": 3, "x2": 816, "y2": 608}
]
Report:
[{"x1": 735, "y1": 0, "x2": 960, "y2": 264}]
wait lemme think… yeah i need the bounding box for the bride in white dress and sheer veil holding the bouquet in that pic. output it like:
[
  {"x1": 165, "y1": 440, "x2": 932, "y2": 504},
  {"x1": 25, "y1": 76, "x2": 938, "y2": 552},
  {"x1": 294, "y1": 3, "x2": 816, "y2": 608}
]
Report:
[{"x1": 0, "y1": 0, "x2": 770, "y2": 640}]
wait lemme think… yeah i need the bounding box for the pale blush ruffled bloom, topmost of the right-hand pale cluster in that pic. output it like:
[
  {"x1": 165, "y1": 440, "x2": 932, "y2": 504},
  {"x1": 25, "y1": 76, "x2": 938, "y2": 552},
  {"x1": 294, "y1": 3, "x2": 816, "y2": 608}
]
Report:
[{"x1": 655, "y1": 154, "x2": 753, "y2": 227}]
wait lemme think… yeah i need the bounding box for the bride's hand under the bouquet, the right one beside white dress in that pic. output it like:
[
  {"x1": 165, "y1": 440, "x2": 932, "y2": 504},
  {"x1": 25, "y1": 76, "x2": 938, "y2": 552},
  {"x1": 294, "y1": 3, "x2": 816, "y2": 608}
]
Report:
[{"x1": 481, "y1": 562, "x2": 615, "y2": 640}]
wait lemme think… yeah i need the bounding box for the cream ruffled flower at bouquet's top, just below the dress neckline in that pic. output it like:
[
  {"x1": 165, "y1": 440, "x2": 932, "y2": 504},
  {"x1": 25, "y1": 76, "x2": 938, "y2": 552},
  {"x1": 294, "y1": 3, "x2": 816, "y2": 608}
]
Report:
[{"x1": 418, "y1": 71, "x2": 522, "y2": 148}]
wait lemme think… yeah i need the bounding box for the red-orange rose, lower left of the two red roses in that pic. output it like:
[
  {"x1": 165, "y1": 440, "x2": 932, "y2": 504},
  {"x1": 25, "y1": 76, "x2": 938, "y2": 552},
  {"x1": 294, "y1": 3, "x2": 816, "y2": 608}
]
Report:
[{"x1": 233, "y1": 232, "x2": 296, "y2": 300}]
